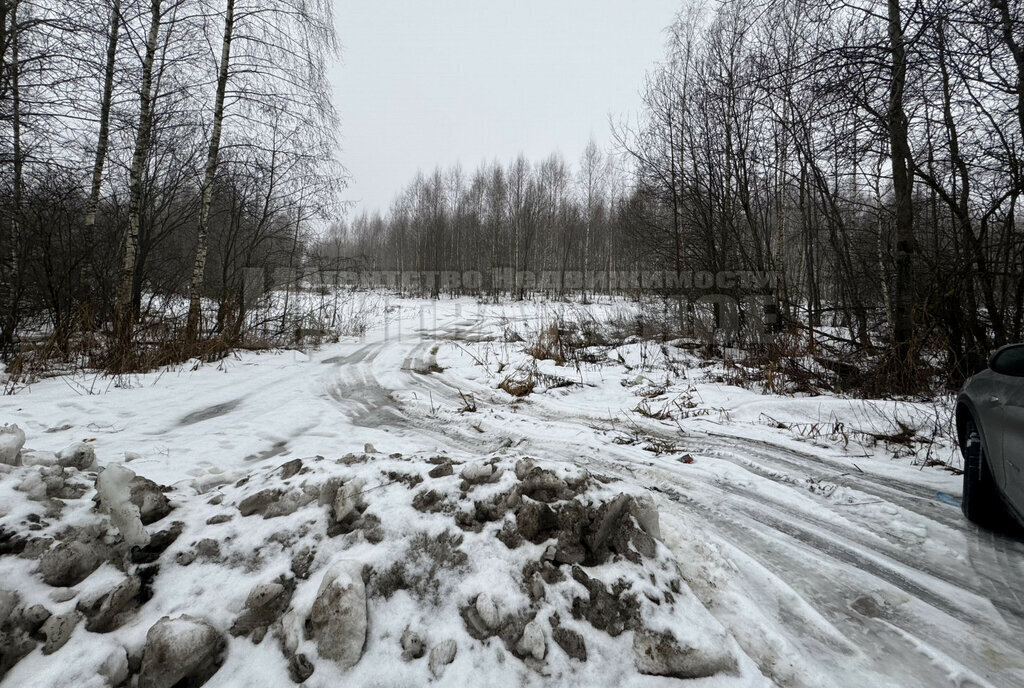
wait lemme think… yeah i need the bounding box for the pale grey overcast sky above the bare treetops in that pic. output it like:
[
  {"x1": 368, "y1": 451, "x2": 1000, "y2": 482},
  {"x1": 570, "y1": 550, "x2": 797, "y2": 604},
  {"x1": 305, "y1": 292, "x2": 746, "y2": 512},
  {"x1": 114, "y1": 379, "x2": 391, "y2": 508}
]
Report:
[{"x1": 332, "y1": 0, "x2": 682, "y2": 212}]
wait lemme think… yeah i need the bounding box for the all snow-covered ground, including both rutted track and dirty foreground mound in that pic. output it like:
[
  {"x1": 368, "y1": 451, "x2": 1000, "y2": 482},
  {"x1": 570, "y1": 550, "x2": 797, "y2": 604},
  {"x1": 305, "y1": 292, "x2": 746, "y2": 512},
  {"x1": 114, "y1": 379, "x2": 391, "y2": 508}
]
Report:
[{"x1": 0, "y1": 299, "x2": 1024, "y2": 687}]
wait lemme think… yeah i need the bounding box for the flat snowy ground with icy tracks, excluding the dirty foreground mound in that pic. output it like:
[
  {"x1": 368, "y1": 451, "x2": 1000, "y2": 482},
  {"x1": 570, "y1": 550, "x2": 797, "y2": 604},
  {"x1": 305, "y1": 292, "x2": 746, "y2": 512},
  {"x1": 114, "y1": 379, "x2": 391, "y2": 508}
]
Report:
[{"x1": 0, "y1": 300, "x2": 1024, "y2": 688}]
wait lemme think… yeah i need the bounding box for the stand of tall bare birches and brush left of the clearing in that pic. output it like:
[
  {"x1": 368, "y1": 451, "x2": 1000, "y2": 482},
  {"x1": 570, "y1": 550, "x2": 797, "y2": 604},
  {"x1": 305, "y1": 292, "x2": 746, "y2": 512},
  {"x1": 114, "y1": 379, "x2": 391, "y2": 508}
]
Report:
[{"x1": 0, "y1": 0, "x2": 343, "y2": 368}]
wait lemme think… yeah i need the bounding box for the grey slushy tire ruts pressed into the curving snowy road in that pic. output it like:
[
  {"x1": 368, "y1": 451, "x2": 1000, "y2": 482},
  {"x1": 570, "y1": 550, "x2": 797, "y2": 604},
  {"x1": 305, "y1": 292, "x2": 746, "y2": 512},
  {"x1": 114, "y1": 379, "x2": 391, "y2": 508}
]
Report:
[{"x1": 325, "y1": 321, "x2": 1024, "y2": 685}]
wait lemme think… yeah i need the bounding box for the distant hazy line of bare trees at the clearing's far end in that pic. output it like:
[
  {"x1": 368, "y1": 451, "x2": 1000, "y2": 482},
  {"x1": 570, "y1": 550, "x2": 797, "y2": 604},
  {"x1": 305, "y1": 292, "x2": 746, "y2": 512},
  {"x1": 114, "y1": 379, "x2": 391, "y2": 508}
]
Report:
[{"x1": 318, "y1": 141, "x2": 637, "y2": 296}]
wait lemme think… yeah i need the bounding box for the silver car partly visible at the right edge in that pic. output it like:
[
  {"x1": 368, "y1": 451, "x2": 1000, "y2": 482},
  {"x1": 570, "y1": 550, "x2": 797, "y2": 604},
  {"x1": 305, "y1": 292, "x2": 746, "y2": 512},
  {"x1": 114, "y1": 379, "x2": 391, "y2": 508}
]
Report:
[{"x1": 955, "y1": 344, "x2": 1024, "y2": 527}]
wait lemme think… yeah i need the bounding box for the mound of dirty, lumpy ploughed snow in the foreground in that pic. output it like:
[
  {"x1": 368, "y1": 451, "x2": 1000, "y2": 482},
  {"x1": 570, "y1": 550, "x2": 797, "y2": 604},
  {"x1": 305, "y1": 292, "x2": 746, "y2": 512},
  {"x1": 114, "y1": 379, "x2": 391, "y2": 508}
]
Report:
[{"x1": 0, "y1": 449, "x2": 761, "y2": 688}]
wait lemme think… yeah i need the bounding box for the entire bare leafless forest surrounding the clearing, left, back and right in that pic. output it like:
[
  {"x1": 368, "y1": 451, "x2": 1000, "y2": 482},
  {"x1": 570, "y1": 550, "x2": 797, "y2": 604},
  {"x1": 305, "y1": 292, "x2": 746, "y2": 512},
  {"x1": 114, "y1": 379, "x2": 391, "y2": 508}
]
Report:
[{"x1": 0, "y1": 0, "x2": 1024, "y2": 392}]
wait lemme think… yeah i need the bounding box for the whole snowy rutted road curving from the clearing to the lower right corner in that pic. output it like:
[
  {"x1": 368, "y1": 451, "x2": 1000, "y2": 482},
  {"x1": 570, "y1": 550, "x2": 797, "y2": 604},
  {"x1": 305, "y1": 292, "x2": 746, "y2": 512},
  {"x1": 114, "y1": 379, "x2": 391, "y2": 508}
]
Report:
[{"x1": 313, "y1": 303, "x2": 1024, "y2": 686}]
